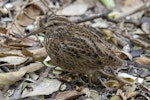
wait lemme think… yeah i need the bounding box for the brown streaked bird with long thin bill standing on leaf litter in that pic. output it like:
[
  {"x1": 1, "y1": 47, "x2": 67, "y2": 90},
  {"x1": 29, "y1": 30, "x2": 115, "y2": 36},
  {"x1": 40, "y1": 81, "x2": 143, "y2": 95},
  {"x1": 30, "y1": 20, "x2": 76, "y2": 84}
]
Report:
[{"x1": 26, "y1": 16, "x2": 124, "y2": 74}]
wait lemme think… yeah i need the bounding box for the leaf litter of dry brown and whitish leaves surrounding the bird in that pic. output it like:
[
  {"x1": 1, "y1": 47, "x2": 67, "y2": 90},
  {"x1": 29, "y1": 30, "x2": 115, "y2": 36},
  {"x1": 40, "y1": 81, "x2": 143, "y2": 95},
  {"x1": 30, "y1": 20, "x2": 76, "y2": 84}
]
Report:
[{"x1": 0, "y1": 0, "x2": 150, "y2": 100}]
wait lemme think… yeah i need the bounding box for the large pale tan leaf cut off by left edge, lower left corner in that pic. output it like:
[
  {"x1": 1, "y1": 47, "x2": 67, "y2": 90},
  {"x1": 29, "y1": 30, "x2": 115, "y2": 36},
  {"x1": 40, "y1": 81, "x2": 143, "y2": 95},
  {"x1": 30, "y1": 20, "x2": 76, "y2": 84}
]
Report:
[{"x1": 0, "y1": 71, "x2": 26, "y2": 88}]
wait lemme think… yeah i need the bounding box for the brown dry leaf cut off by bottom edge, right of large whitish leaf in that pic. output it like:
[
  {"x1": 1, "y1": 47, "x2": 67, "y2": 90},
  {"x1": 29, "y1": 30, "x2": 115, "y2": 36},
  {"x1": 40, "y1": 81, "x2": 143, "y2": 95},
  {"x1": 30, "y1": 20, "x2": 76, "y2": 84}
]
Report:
[{"x1": 55, "y1": 90, "x2": 83, "y2": 100}]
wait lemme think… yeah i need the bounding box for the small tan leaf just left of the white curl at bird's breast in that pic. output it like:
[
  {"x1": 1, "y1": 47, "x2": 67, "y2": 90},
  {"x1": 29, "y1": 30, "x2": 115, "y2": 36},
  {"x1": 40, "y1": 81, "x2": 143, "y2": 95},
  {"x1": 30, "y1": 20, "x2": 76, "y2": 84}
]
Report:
[{"x1": 20, "y1": 62, "x2": 44, "y2": 73}]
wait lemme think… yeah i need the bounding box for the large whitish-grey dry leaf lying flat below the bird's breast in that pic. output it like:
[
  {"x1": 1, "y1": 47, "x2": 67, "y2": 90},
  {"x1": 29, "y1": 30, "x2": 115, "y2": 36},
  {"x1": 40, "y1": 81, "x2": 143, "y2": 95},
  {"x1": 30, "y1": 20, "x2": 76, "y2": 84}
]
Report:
[{"x1": 21, "y1": 78, "x2": 61, "y2": 98}]
